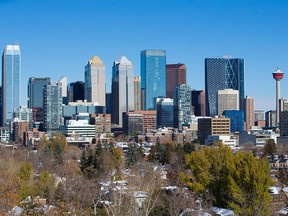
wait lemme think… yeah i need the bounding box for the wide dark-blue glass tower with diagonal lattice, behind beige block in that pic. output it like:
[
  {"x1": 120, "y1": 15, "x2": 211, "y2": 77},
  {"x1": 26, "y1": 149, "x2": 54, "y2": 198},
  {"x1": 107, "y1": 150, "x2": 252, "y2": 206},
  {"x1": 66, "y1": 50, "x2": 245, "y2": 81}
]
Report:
[{"x1": 205, "y1": 58, "x2": 245, "y2": 116}]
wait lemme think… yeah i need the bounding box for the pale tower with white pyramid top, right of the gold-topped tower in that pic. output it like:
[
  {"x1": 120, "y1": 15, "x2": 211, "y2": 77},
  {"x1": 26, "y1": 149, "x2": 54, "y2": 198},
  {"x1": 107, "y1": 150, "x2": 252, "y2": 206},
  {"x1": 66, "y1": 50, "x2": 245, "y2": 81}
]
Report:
[{"x1": 112, "y1": 56, "x2": 134, "y2": 127}]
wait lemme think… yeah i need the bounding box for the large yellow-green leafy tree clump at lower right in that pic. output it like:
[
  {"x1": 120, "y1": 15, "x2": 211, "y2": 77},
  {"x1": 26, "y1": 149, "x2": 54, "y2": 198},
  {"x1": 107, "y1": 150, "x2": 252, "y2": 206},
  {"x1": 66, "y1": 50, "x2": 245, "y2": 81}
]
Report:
[{"x1": 181, "y1": 144, "x2": 272, "y2": 215}]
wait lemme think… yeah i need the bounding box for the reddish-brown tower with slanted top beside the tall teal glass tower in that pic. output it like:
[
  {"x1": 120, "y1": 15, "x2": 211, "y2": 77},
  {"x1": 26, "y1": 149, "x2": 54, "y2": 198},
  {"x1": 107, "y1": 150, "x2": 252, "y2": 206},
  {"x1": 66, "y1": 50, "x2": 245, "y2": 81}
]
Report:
[{"x1": 166, "y1": 64, "x2": 186, "y2": 98}]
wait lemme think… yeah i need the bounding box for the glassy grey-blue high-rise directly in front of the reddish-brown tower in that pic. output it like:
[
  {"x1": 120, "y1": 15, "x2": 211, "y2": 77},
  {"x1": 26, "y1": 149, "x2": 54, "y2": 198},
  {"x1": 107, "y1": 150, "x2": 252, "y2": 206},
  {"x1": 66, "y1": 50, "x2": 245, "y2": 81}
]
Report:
[{"x1": 173, "y1": 84, "x2": 191, "y2": 132}]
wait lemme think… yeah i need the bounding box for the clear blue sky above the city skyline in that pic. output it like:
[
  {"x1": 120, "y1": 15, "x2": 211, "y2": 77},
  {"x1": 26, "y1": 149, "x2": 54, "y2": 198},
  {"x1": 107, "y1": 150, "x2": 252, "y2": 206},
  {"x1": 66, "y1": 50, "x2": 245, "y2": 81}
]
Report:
[{"x1": 0, "y1": 0, "x2": 288, "y2": 110}]
